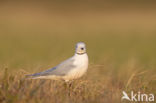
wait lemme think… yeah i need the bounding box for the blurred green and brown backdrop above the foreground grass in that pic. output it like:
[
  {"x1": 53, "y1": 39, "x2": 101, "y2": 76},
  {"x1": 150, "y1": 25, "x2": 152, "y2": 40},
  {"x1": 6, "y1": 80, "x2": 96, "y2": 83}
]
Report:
[{"x1": 0, "y1": 0, "x2": 156, "y2": 70}]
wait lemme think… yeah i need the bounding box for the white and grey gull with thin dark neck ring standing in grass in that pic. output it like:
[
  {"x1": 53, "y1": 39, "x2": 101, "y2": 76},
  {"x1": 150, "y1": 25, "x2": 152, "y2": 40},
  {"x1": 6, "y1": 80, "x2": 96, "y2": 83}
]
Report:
[{"x1": 28, "y1": 42, "x2": 88, "y2": 81}]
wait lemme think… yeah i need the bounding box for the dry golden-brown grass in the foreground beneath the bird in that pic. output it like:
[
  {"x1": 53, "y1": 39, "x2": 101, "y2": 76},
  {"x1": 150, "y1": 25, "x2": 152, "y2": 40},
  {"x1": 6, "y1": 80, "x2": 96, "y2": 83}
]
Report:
[{"x1": 0, "y1": 61, "x2": 156, "y2": 103}]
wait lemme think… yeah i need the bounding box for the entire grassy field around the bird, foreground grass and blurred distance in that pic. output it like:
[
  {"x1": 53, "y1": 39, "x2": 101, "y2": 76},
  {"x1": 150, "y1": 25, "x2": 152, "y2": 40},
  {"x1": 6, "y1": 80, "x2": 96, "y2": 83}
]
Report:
[{"x1": 0, "y1": 1, "x2": 156, "y2": 103}]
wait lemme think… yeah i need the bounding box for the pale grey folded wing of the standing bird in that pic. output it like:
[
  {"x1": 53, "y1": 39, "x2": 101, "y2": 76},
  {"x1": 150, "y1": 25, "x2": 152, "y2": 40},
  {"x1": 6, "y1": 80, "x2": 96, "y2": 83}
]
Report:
[{"x1": 31, "y1": 58, "x2": 76, "y2": 76}]
